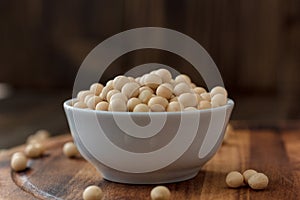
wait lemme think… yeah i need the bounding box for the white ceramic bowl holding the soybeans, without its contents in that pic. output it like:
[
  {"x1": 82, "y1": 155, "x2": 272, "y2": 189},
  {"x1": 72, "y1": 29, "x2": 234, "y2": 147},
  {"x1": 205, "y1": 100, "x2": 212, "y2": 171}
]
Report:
[{"x1": 64, "y1": 100, "x2": 234, "y2": 184}]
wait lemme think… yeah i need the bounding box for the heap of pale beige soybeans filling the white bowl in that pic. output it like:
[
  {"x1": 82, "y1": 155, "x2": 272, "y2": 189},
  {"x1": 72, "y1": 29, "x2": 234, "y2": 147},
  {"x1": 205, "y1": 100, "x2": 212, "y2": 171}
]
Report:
[{"x1": 72, "y1": 69, "x2": 228, "y2": 112}]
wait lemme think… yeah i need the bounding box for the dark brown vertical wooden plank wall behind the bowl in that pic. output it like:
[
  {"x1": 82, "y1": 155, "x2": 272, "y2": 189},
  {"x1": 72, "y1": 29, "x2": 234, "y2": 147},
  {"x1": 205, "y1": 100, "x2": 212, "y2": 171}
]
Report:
[{"x1": 0, "y1": 0, "x2": 300, "y2": 108}]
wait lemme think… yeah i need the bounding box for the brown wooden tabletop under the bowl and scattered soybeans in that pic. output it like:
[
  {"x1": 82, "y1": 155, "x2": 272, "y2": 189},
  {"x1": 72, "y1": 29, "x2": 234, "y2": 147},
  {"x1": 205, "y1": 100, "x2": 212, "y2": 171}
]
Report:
[{"x1": 0, "y1": 124, "x2": 300, "y2": 200}]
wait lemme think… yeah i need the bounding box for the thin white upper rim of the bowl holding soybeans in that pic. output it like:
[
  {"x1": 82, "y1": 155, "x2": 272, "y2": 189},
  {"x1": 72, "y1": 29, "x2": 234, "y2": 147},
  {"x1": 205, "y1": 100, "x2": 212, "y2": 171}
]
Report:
[{"x1": 63, "y1": 98, "x2": 234, "y2": 116}]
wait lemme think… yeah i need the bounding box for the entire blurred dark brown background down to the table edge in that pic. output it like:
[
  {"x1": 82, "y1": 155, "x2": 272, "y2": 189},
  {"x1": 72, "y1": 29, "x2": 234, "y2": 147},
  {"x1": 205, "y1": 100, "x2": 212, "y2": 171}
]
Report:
[{"x1": 0, "y1": 0, "x2": 300, "y2": 148}]
